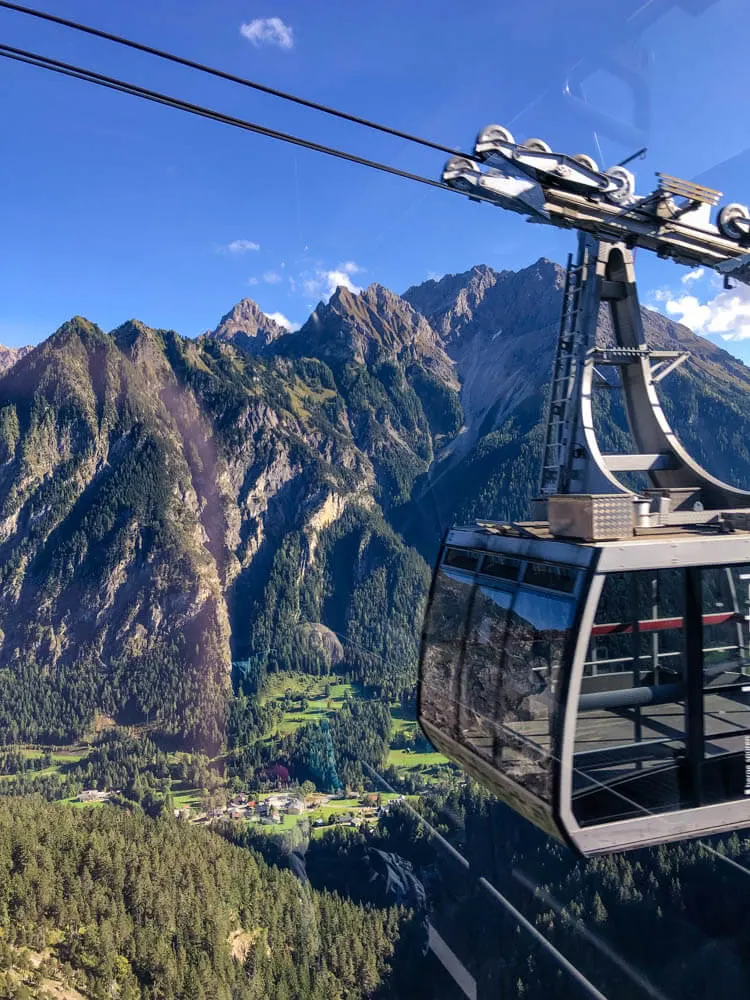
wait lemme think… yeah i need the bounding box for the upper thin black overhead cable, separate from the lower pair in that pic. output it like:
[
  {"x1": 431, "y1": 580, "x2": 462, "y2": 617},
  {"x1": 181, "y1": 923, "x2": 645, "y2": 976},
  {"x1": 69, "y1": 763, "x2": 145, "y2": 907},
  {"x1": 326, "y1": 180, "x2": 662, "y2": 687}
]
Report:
[{"x1": 0, "y1": 0, "x2": 474, "y2": 159}]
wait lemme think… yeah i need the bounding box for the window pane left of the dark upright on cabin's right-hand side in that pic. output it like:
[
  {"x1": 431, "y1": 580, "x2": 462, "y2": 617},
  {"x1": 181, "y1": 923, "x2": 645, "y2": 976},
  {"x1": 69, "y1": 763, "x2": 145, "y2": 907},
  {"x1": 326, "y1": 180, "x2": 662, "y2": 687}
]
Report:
[{"x1": 573, "y1": 569, "x2": 692, "y2": 825}]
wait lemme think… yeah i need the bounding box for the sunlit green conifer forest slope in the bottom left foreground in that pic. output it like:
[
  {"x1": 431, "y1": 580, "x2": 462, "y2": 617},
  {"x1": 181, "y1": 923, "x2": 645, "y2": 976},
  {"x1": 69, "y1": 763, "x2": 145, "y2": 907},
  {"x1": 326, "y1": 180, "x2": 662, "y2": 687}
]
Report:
[{"x1": 0, "y1": 798, "x2": 412, "y2": 1000}]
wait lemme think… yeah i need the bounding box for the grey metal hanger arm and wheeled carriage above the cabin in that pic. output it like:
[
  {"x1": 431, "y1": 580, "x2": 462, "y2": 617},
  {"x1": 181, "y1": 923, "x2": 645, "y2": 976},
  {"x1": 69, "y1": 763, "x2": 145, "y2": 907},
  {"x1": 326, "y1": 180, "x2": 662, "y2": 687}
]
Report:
[{"x1": 443, "y1": 132, "x2": 750, "y2": 540}]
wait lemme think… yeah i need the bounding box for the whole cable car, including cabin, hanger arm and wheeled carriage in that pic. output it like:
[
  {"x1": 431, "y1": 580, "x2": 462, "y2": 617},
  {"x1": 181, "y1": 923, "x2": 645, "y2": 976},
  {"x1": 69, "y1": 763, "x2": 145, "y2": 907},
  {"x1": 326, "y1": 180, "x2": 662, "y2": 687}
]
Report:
[{"x1": 418, "y1": 126, "x2": 750, "y2": 855}]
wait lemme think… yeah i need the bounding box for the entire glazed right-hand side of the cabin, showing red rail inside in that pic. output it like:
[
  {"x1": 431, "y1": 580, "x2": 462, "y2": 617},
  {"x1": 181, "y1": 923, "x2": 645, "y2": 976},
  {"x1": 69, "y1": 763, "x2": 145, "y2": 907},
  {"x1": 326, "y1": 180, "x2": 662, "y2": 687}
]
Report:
[{"x1": 574, "y1": 566, "x2": 750, "y2": 823}]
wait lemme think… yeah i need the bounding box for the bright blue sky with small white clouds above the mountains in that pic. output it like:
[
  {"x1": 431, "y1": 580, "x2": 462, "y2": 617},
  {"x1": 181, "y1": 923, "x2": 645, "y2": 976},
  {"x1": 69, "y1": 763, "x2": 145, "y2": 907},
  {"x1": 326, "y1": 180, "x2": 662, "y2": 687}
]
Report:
[{"x1": 0, "y1": 0, "x2": 750, "y2": 361}]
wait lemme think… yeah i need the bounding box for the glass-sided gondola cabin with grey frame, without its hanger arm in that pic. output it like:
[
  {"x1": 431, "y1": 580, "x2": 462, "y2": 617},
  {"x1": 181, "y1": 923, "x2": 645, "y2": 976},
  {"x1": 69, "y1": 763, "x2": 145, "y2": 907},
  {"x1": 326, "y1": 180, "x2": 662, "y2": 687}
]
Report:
[{"x1": 419, "y1": 523, "x2": 750, "y2": 855}]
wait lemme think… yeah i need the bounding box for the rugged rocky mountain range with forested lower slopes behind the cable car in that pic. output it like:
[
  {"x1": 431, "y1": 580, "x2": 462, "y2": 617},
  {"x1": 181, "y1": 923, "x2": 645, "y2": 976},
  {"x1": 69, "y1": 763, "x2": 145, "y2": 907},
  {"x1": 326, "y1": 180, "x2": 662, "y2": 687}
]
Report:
[{"x1": 0, "y1": 259, "x2": 750, "y2": 747}]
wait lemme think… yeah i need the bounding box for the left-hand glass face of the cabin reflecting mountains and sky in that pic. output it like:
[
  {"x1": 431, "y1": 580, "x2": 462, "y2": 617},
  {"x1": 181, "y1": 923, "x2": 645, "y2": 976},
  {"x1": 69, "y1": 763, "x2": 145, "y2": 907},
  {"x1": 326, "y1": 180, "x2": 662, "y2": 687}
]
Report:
[{"x1": 421, "y1": 549, "x2": 580, "y2": 802}]
